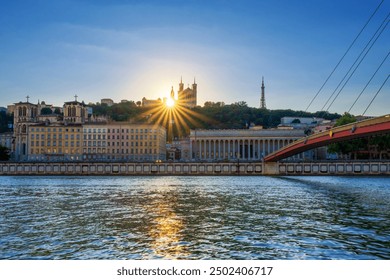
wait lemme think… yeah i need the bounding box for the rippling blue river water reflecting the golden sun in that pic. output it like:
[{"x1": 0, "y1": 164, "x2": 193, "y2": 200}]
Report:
[{"x1": 0, "y1": 177, "x2": 390, "y2": 259}]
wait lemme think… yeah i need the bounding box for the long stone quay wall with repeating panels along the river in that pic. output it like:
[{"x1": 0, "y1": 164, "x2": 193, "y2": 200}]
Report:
[{"x1": 0, "y1": 161, "x2": 390, "y2": 176}]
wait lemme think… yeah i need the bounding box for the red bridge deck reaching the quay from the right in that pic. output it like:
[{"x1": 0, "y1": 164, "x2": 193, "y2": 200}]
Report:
[{"x1": 264, "y1": 115, "x2": 390, "y2": 162}]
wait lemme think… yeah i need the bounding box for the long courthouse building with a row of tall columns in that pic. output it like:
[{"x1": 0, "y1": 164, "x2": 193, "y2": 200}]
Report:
[{"x1": 189, "y1": 129, "x2": 305, "y2": 161}]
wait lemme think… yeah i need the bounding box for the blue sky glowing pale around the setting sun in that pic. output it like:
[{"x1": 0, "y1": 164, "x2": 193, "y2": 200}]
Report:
[{"x1": 0, "y1": 0, "x2": 390, "y2": 115}]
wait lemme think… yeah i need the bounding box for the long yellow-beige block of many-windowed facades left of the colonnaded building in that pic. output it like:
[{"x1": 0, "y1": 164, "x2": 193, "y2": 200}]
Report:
[{"x1": 27, "y1": 123, "x2": 166, "y2": 161}]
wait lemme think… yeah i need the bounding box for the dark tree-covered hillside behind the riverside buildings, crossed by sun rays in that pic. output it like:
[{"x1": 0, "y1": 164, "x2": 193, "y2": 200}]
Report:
[{"x1": 89, "y1": 101, "x2": 341, "y2": 136}]
